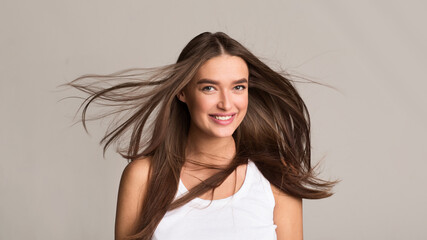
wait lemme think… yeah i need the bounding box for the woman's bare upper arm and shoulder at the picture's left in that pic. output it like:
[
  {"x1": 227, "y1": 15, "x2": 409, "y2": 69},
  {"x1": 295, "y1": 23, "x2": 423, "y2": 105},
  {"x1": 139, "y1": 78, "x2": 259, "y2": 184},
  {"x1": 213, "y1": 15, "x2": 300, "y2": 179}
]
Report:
[{"x1": 115, "y1": 158, "x2": 150, "y2": 240}]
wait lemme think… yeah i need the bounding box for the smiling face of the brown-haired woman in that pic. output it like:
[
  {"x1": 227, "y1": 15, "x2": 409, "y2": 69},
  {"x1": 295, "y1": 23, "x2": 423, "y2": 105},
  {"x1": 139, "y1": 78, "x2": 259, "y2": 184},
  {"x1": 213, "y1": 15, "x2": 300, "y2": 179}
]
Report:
[{"x1": 178, "y1": 54, "x2": 249, "y2": 137}]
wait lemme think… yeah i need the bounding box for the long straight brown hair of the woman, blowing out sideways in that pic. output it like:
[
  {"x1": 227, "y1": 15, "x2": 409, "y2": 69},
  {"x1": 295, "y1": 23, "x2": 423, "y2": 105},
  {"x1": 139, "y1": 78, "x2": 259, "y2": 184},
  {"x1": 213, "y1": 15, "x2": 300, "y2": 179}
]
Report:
[{"x1": 69, "y1": 32, "x2": 335, "y2": 239}]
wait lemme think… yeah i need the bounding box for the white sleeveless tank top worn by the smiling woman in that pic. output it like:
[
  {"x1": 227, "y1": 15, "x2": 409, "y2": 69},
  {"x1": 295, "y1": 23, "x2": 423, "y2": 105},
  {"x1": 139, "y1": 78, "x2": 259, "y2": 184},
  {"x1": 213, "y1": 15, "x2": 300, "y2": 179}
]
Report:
[{"x1": 153, "y1": 160, "x2": 277, "y2": 240}]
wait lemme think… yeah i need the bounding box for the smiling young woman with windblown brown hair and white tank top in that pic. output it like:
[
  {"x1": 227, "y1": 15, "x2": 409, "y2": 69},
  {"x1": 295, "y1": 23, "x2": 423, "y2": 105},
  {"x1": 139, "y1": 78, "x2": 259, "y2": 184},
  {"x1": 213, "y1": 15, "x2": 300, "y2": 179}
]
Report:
[{"x1": 70, "y1": 32, "x2": 334, "y2": 240}]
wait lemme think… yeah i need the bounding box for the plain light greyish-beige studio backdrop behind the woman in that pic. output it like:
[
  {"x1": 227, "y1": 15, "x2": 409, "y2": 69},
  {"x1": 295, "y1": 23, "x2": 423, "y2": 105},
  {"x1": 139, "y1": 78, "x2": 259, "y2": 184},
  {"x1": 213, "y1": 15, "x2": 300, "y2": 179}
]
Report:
[{"x1": 0, "y1": 0, "x2": 427, "y2": 240}]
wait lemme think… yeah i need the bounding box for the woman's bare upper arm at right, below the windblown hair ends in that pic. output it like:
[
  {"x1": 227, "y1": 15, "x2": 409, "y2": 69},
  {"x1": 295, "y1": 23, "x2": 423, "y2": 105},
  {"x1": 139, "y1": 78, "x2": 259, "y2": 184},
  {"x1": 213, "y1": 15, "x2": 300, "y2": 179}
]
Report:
[{"x1": 271, "y1": 185, "x2": 303, "y2": 240}]
